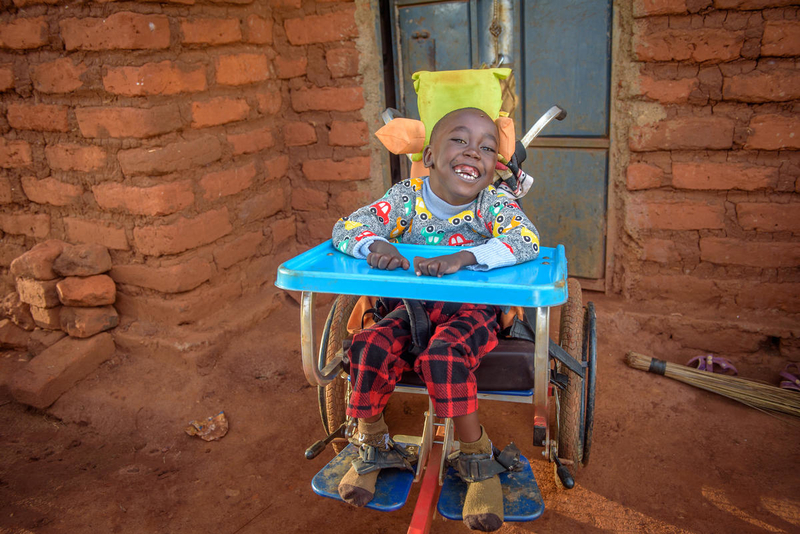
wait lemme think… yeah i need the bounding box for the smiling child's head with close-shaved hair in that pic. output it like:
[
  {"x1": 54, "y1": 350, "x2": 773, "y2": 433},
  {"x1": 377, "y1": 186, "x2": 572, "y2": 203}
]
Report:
[{"x1": 422, "y1": 109, "x2": 498, "y2": 206}]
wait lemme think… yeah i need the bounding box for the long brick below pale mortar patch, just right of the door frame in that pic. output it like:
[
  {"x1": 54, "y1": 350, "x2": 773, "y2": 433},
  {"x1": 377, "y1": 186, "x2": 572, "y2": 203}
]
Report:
[{"x1": 629, "y1": 117, "x2": 734, "y2": 152}]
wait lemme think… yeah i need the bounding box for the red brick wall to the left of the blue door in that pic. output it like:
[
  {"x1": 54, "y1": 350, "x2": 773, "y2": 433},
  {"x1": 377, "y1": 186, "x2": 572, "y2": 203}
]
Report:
[{"x1": 0, "y1": 0, "x2": 384, "y2": 344}]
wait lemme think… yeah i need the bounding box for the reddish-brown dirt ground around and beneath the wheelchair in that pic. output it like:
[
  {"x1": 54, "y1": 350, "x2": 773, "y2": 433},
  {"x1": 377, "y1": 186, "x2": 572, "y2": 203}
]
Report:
[{"x1": 0, "y1": 292, "x2": 800, "y2": 534}]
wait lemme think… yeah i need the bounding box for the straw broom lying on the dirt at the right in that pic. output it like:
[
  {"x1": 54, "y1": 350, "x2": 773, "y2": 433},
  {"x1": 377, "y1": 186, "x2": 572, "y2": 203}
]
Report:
[{"x1": 625, "y1": 351, "x2": 800, "y2": 417}]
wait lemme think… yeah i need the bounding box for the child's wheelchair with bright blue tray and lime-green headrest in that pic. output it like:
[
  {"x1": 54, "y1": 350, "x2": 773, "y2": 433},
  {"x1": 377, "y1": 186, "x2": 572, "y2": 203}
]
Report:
[{"x1": 276, "y1": 69, "x2": 597, "y2": 532}]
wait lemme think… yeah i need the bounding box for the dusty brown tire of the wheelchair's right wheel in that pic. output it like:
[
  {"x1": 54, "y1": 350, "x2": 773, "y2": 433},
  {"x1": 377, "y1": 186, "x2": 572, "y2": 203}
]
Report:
[{"x1": 556, "y1": 278, "x2": 584, "y2": 476}]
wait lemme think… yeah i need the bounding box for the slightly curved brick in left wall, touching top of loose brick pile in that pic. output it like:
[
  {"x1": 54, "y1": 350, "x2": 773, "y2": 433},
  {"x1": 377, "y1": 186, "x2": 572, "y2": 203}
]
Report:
[{"x1": 108, "y1": 258, "x2": 214, "y2": 293}]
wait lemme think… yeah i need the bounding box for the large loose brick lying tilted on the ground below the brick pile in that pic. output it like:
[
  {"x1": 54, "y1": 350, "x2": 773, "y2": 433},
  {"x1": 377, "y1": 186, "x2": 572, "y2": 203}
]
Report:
[{"x1": 11, "y1": 334, "x2": 116, "y2": 408}]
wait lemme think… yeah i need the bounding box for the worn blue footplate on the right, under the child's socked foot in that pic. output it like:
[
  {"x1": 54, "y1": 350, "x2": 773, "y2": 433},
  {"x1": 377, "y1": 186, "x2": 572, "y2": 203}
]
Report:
[{"x1": 437, "y1": 456, "x2": 544, "y2": 522}]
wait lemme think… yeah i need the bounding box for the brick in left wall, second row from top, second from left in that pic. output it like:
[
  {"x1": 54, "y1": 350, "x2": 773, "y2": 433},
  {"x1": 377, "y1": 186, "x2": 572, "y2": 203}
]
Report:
[{"x1": 103, "y1": 61, "x2": 207, "y2": 96}]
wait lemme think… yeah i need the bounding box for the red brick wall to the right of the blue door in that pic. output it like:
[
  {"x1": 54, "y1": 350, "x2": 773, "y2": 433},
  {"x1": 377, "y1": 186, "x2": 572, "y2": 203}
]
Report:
[{"x1": 614, "y1": 0, "x2": 800, "y2": 352}]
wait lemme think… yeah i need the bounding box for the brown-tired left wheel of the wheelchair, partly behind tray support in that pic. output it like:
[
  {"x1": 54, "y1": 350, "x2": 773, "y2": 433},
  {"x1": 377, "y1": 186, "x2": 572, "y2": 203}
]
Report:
[{"x1": 317, "y1": 295, "x2": 359, "y2": 454}]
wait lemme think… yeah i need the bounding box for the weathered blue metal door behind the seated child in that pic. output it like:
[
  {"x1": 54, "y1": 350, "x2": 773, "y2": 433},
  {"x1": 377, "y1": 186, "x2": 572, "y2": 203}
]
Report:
[{"x1": 391, "y1": 0, "x2": 611, "y2": 280}]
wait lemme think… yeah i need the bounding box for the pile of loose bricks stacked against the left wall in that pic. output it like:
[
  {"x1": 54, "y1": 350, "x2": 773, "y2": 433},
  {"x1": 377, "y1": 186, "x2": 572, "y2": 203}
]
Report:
[{"x1": 0, "y1": 240, "x2": 119, "y2": 408}]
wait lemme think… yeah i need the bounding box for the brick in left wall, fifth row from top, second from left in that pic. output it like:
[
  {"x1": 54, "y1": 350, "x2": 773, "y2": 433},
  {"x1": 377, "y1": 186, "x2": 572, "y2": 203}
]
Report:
[{"x1": 92, "y1": 180, "x2": 194, "y2": 217}]
